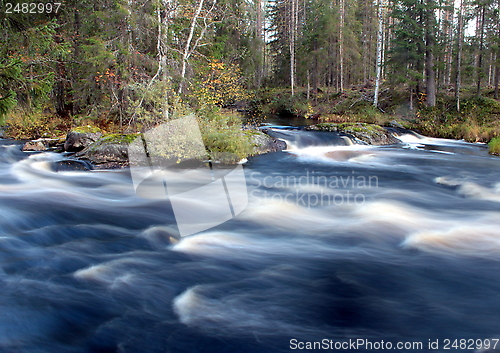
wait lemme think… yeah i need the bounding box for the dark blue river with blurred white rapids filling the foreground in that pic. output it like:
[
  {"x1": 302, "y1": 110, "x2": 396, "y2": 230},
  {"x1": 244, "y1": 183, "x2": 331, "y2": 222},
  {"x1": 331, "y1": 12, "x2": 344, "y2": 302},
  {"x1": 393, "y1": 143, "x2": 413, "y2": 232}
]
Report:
[{"x1": 0, "y1": 128, "x2": 500, "y2": 353}]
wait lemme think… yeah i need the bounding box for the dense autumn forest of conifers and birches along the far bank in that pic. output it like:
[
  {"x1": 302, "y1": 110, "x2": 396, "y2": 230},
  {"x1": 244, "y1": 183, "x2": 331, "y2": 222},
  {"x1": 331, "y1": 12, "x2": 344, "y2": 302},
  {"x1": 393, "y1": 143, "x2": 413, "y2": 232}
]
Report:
[{"x1": 0, "y1": 0, "x2": 500, "y2": 153}]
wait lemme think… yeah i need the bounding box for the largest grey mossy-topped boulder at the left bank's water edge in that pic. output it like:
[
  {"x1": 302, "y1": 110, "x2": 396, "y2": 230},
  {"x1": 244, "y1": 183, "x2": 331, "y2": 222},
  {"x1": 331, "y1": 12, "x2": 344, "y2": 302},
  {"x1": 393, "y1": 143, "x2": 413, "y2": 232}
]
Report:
[{"x1": 75, "y1": 134, "x2": 138, "y2": 169}]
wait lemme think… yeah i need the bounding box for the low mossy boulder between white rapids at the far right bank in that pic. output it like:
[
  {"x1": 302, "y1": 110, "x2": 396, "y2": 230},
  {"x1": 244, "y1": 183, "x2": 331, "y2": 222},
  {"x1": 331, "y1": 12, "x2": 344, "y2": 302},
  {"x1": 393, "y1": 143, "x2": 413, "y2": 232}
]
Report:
[{"x1": 305, "y1": 123, "x2": 400, "y2": 145}]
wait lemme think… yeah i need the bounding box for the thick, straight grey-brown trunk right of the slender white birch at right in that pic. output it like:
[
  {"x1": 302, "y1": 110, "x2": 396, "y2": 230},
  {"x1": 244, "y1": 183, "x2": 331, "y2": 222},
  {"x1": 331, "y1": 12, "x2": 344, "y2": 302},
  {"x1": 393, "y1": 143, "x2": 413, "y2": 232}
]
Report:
[{"x1": 425, "y1": 0, "x2": 436, "y2": 107}]
